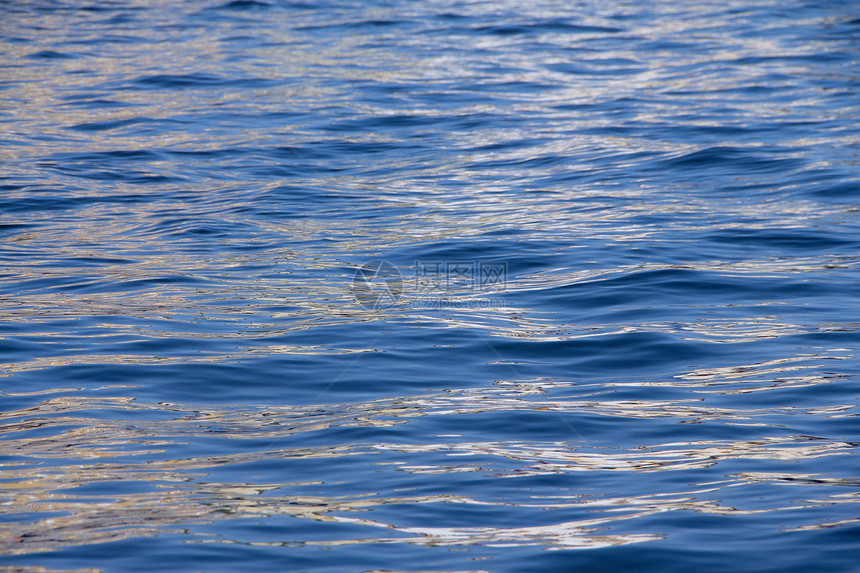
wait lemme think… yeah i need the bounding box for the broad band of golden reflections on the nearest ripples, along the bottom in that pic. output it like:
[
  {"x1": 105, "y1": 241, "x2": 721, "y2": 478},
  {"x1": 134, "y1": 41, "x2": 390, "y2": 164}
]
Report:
[{"x1": 0, "y1": 349, "x2": 860, "y2": 554}]
